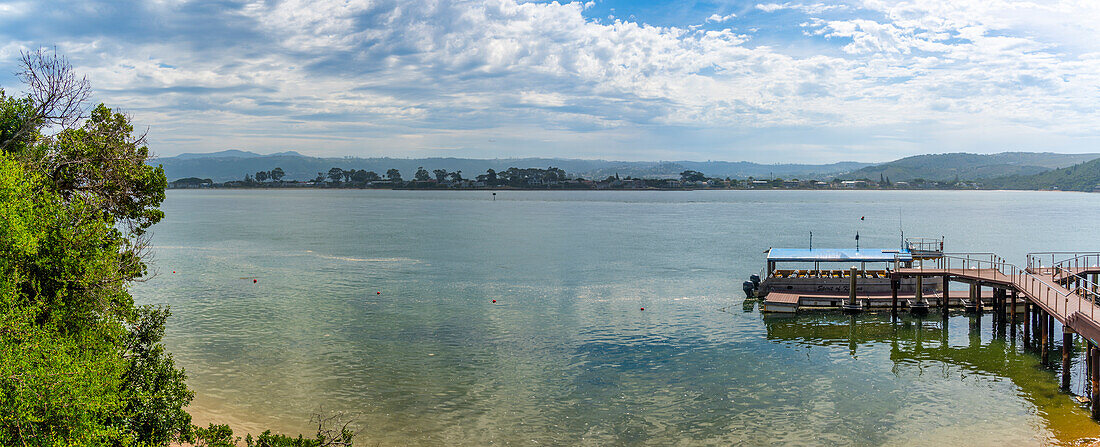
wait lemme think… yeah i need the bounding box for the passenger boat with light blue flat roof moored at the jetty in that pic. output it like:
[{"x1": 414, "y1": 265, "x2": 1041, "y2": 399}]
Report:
[{"x1": 743, "y1": 238, "x2": 944, "y2": 313}]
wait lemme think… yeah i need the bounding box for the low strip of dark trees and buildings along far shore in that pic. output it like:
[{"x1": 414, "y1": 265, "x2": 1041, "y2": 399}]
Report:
[{"x1": 168, "y1": 167, "x2": 982, "y2": 189}]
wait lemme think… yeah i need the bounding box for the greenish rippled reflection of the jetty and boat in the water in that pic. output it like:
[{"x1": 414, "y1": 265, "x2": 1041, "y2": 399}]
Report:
[{"x1": 765, "y1": 310, "x2": 1097, "y2": 443}]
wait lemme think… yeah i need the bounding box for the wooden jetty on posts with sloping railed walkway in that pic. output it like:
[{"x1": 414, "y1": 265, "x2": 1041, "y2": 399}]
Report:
[{"x1": 766, "y1": 252, "x2": 1100, "y2": 419}]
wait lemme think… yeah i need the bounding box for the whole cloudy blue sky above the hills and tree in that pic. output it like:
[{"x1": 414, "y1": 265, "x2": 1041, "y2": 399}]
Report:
[{"x1": 0, "y1": 0, "x2": 1100, "y2": 163}]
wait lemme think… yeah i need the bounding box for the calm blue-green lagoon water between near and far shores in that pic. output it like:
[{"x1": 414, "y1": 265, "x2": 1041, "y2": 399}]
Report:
[{"x1": 134, "y1": 190, "x2": 1100, "y2": 445}]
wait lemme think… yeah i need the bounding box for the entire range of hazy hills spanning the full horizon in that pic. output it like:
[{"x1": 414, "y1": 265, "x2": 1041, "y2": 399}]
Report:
[{"x1": 150, "y1": 150, "x2": 1100, "y2": 184}]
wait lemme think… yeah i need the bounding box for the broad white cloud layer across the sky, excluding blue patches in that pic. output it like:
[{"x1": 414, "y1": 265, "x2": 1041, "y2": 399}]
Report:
[{"x1": 0, "y1": 0, "x2": 1100, "y2": 159}]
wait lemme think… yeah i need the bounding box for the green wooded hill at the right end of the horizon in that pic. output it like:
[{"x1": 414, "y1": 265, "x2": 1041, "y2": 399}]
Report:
[{"x1": 839, "y1": 152, "x2": 1100, "y2": 182}]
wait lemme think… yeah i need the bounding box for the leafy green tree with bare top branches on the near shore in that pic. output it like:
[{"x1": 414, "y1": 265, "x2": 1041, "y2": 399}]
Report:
[{"x1": 0, "y1": 53, "x2": 191, "y2": 446}]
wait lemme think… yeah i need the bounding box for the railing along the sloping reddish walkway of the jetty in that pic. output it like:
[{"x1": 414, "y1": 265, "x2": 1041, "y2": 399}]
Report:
[{"x1": 894, "y1": 253, "x2": 1100, "y2": 321}]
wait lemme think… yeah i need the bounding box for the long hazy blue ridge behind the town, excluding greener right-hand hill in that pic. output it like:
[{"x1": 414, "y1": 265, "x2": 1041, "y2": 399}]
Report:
[{"x1": 150, "y1": 150, "x2": 869, "y2": 182}]
